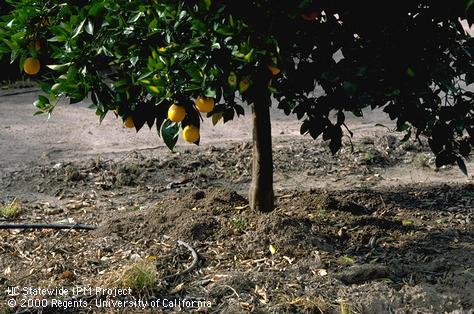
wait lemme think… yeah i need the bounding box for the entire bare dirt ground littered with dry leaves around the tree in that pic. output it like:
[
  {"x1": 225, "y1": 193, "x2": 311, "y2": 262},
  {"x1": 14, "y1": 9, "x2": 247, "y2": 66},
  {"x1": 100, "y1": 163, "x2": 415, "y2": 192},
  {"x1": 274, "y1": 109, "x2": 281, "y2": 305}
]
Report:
[{"x1": 0, "y1": 92, "x2": 474, "y2": 313}]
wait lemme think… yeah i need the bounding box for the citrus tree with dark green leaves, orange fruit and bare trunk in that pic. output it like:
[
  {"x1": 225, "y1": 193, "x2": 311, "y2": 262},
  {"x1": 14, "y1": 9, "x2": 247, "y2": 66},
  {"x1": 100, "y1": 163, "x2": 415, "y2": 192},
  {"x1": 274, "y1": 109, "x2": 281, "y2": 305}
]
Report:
[{"x1": 0, "y1": 0, "x2": 474, "y2": 211}]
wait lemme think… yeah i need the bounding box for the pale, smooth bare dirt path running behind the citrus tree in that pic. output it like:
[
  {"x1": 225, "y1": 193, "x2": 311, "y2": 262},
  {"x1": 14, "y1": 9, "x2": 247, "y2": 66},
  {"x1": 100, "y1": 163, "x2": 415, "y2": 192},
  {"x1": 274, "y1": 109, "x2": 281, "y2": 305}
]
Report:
[{"x1": 0, "y1": 89, "x2": 474, "y2": 188}]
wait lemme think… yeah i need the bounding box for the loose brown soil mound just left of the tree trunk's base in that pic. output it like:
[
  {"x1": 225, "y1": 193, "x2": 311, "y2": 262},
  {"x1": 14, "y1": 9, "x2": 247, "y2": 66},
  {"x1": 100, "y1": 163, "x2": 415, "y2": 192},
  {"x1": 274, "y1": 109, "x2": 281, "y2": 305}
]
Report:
[{"x1": 96, "y1": 188, "x2": 247, "y2": 241}]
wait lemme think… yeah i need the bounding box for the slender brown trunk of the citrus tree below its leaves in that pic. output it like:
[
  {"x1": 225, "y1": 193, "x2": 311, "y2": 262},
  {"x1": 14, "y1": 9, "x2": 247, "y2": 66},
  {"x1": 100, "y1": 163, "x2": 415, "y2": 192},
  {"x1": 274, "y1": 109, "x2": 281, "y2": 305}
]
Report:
[{"x1": 249, "y1": 94, "x2": 273, "y2": 212}]
